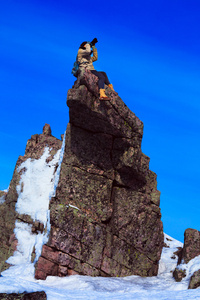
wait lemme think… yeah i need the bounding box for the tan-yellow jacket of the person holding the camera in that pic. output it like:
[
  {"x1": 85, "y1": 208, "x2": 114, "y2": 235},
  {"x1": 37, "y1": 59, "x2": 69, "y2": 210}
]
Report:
[{"x1": 77, "y1": 44, "x2": 98, "y2": 70}]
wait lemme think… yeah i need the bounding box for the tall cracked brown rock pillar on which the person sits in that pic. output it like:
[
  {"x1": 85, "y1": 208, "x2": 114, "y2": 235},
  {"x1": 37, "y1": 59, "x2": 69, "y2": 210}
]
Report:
[{"x1": 35, "y1": 71, "x2": 163, "y2": 279}]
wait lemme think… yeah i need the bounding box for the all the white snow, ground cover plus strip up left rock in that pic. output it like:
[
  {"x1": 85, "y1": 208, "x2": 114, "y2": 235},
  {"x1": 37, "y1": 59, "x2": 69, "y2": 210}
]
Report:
[{"x1": 0, "y1": 139, "x2": 200, "y2": 300}]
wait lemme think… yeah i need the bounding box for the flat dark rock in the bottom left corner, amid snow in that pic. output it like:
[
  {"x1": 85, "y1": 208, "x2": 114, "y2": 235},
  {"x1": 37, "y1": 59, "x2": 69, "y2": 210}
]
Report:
[{"x1": 0, "y1": 292, "x2": 47, "y2": 300}]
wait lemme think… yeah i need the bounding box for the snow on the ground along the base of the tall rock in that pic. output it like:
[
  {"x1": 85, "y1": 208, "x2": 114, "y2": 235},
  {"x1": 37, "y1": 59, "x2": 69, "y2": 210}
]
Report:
[{"x1": 0, "y1": 234, "x2": 200, "y2": 300}]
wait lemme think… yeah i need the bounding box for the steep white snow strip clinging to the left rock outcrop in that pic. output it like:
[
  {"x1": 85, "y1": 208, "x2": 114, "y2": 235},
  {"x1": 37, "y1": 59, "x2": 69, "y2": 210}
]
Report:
[{"x1": 5, "y1": 134, "x2": 65, "y2": 275}]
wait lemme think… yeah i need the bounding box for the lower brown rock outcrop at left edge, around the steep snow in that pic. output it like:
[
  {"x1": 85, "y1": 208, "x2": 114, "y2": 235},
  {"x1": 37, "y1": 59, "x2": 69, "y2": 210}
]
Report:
[{"x1": 0, "y1": 124, "x2": 62, "y2": 273}]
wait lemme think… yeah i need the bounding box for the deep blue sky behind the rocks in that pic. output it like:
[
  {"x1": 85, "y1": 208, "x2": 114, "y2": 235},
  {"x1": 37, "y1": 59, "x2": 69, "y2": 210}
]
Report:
[{"x1": 0, "y1": 0, "x2": 200, "y2": 241}]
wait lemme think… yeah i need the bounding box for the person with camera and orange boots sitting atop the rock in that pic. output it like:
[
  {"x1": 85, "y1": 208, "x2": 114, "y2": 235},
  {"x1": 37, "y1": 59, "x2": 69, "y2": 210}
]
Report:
[{"x1": 77, "y1": 38, "x2": 114, "y2": 100}]
